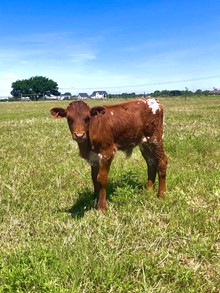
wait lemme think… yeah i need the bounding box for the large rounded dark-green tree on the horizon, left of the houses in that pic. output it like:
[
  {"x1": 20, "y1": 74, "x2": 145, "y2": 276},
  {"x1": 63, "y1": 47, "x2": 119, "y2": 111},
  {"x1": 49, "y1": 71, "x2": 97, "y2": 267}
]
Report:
[{"x1": 11, "y1": 76, "x2": 60, "y2": 100}]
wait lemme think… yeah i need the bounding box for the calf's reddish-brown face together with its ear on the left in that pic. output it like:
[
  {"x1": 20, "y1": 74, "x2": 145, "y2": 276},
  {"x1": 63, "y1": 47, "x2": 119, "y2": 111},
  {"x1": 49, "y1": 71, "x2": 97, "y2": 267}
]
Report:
[{"x1": 50, "y1": 101, "x2": 90, "y2": 143}]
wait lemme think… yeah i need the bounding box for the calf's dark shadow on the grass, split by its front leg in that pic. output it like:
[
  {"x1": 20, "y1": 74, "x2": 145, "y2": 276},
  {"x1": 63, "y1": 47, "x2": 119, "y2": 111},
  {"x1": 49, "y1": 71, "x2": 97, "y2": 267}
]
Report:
[{"x1": 65, "y1": 171, "x2": 145, "y2": 219}]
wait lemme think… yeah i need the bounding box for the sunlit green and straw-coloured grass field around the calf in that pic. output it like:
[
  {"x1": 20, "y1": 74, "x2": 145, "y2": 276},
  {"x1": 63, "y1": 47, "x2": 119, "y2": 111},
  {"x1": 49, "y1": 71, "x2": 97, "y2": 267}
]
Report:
[{"x1": 0, "y1": 97, "x2": 220, "y2": 293}]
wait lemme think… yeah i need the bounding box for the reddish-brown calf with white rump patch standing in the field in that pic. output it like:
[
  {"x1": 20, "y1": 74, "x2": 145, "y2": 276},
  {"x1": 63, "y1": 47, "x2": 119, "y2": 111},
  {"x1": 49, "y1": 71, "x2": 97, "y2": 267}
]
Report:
[{"x1": 50, "y1": 98, "x2": 167, "y2": 211}]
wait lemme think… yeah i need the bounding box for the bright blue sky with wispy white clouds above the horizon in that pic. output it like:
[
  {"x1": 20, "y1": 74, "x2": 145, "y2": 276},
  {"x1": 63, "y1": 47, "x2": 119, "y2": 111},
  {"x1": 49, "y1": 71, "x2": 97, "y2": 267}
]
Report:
[{"x1": 0, "y1": 0, "x2": 220, "y2": 96}]
